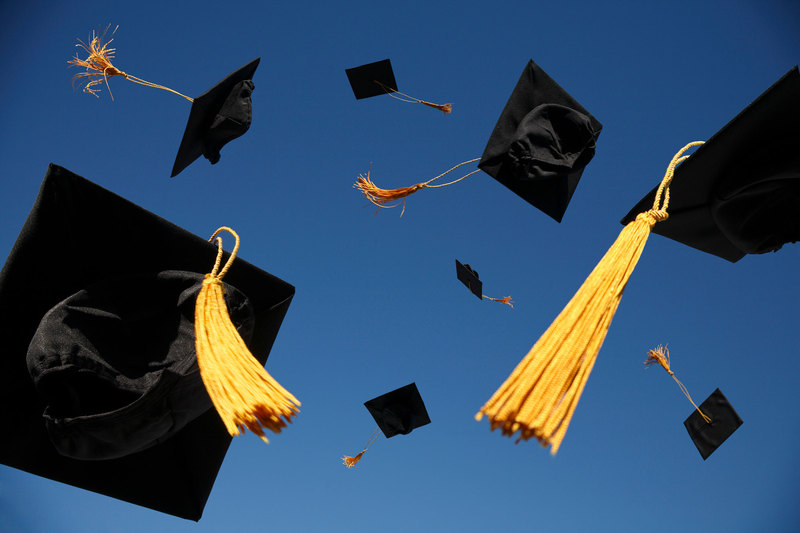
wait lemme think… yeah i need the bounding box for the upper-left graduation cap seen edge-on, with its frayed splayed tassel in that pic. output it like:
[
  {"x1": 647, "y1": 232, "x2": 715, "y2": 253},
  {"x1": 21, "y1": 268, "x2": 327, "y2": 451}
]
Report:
[{"x1": 68, "y1": 26, "x2": 261, "y2": 178}]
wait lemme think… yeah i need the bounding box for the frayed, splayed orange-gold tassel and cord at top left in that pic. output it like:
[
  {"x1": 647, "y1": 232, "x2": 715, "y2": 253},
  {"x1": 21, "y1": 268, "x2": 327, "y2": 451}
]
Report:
[{"x1": 67, "y1": 24, "x2": 194, "y2": 102}]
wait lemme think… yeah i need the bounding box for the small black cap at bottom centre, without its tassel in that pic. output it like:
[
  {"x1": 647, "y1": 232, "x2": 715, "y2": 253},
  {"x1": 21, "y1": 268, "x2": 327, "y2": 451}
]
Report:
[{"x1": 364, "y1": 383, "x2": 431, "y2": 439}]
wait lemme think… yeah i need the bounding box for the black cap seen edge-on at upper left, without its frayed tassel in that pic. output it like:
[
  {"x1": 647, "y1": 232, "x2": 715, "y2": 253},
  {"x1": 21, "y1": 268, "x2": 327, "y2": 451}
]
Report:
[{"x1": 171, "y1": 57, "x2": 261, "y2": 178}]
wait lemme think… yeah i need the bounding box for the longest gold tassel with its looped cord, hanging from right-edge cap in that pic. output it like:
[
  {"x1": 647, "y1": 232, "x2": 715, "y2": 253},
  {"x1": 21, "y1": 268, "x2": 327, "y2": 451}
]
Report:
[{"x1": 475, "y1": 141, "x2": 703, "y2": 455}]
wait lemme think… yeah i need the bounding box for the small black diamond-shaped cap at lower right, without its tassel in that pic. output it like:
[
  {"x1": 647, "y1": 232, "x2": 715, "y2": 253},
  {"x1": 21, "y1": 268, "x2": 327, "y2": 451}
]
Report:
[{"x1": 683, "y1": 389, "x2": 742, "y2": 460}]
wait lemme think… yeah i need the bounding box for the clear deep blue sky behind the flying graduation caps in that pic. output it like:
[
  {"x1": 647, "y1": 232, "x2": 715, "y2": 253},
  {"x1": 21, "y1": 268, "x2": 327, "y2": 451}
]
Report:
[{"x1": 0, "y1": 0, "x2": 800, "y2": 533}]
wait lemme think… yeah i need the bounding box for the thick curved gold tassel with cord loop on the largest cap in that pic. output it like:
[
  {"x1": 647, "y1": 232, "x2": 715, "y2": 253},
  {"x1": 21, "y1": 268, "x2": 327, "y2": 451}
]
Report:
[{"x1": 194, "y1": 227, "x2": 300, "y2": 442}]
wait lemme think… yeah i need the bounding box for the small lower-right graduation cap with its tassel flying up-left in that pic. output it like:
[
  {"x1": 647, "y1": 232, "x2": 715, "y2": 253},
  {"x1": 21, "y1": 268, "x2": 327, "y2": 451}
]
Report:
[{"x1": 644, "y1": 346, "x2": 742, "y2": 460}]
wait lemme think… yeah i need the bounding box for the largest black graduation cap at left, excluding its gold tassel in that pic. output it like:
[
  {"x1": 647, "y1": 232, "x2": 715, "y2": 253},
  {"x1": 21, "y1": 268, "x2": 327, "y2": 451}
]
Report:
[{"x1": 0, "y1": 164, "x2": 294, "y2": 520}]
